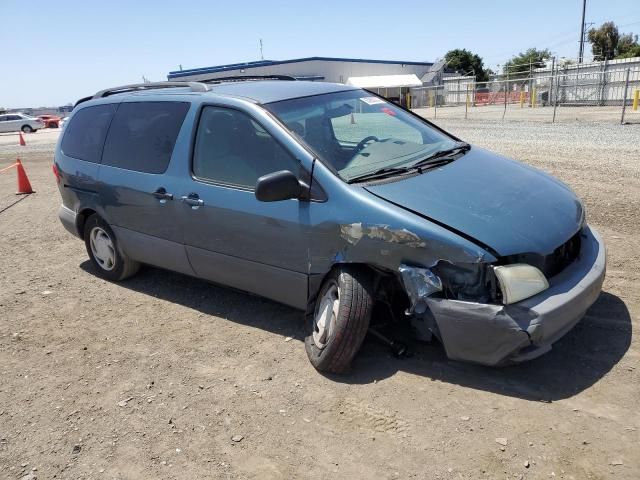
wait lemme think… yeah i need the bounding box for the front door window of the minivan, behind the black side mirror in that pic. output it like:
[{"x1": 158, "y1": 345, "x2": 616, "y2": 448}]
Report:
[{"x1": 193, "y1": 106, "x2": 299, "y2": 188}]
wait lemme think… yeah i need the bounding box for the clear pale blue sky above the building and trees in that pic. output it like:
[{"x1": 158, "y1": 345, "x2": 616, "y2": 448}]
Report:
[{"x1": 0, "y1": 0, "x2": 640, "y2": 108}]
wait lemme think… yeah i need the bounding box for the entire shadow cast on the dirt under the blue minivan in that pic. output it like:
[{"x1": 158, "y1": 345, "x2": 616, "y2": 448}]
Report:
[{"x1": 80, "y1": 260, "x2": 632, "y2": 402}]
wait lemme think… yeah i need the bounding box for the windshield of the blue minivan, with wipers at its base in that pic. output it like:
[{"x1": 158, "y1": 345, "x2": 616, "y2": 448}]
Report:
[{"x1": 265, "y1": 90, "x2": 457, "y2": 181}]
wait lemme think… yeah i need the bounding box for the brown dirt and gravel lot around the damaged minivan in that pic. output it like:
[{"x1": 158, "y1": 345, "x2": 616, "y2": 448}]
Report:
[{"x1": 0, "y1": 124, "x2": 640, "y2": 480}]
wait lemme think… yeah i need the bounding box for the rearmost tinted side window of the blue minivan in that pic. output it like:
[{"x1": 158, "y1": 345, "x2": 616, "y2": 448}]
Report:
[{"x1": 60, "y1": 103, "x2": 116, "y2": 163}]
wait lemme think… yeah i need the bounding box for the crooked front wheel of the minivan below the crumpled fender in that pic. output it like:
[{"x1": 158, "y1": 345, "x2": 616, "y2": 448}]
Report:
[{"x1": 305, "y1": 265, "x2": 373, "y2": 373}]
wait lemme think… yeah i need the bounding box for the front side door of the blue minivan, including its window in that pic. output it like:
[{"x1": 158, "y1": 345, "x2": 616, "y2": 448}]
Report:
[{"x1": 181, "y1": 106, "x2": 313, "y2": 308}]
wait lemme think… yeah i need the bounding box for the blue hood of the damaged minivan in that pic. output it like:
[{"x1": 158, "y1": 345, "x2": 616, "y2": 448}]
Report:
[{"x1": 365, "y1": 146, "x2": 583, "y2": 256}]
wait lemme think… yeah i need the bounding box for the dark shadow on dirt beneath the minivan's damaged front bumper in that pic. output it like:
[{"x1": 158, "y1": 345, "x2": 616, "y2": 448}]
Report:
[{"x1": 344, "y1": 292, "x2": 632, "y2": 402}]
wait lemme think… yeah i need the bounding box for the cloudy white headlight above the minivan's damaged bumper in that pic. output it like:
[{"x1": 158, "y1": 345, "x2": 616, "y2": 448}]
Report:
[{"x1": 493, "y1": 263, "x2": 549, "y2": 305}]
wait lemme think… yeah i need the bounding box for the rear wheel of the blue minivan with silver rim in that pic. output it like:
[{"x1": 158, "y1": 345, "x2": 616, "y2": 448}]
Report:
[{"x1": 84, "y1": 214, "x2": 140, "y2": 282}]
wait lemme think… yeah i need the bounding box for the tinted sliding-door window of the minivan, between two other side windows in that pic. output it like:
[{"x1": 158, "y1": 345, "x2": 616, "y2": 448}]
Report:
[{"x1": 102, "y1": 102, "x2": 190, "y2": 173}]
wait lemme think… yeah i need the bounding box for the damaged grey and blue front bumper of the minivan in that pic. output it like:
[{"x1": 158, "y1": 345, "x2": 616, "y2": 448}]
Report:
[{"x1": 427, "y1": 227, "x2": 606, "y2": 365}]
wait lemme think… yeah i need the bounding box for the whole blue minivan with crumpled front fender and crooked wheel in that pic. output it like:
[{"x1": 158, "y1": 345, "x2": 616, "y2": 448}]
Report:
[{"x1": 53, "y1": 77, "x2": 606, "y2": 372}]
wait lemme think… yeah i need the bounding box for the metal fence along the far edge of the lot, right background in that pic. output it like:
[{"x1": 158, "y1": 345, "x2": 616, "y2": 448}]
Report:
[{"x1": 410, "y1": 68, "x2": 640, "y2": 123}]
